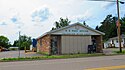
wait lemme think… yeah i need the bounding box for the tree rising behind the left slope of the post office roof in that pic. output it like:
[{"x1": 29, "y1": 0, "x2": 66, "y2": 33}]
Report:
[{"x1": 52, "y1": 18, "x2": 71, "y2": 30}]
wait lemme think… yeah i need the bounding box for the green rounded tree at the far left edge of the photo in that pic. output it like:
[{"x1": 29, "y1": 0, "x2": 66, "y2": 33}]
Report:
[{"x1": 0, "y1": 36, "x2": 11, "y2": 48}]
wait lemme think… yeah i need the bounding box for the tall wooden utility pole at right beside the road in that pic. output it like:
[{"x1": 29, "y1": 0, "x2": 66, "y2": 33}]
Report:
[{"x1": 116, "y1": 0, "x2": 122, "y2": 52}]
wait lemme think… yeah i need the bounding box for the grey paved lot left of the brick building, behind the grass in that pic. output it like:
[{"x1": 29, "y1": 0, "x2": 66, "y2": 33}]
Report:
[{"x1": 0, "y1": 51, "x2": 41, "y2": 58}]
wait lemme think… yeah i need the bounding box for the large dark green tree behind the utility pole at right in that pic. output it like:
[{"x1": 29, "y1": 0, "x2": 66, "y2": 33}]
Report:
[{"x1": 96, "y1": 15, "x2": 125, "y2": 40}]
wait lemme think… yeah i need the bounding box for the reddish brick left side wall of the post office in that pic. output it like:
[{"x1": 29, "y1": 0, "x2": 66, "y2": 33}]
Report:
[{"x1": 37, "y1": 35, "x2": 51, "y2": 54}]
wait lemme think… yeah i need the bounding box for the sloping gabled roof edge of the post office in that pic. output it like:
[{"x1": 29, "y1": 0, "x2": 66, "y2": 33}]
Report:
[{"x1": 37, "y1": 23, "x2": 105, "y2": 39}]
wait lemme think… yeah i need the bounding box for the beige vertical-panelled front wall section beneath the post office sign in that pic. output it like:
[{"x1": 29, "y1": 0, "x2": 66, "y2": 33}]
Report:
[{"x1": 61, "y1": 36, "x2": 91, "y2": 54}]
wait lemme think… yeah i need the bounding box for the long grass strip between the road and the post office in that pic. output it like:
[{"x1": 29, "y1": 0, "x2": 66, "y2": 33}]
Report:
[{"x1": 0, "y1": 53, "x2": 104, "y2": 62}]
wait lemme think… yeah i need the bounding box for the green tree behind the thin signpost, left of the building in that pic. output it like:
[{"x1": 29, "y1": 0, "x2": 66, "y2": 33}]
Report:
[{"x1": 13, "y1": 35, "x2": 32, "y2": 50}]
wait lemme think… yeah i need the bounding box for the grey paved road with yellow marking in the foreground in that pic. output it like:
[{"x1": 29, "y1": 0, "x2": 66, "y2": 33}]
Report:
[{"x1": 0, "y1": 55, "x2": 125, "y2": 70}]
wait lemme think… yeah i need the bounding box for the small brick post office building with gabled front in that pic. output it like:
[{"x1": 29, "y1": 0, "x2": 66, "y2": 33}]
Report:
[{"x1": 37, "y1": 23, "x2": 104, "y2": 54}]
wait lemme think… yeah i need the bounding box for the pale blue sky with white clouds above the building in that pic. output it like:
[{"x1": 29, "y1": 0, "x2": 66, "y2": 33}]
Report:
[{"x1": 0, "y1": 0, "x2": 125, "y2": 43}]
